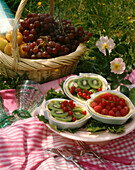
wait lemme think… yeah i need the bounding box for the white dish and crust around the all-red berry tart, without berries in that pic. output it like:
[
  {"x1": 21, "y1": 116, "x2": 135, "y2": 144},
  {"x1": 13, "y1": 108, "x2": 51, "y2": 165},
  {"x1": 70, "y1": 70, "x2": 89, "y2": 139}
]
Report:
[{"x1": 86, "y1": 90, "x2": 135, "y2": 125}]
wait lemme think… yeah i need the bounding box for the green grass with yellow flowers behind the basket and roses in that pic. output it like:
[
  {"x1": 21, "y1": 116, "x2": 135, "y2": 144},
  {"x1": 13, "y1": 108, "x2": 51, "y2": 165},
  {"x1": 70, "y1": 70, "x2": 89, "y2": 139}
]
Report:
[{"x1": 0, "y1": 0, "x2": 135, "y2": 89}]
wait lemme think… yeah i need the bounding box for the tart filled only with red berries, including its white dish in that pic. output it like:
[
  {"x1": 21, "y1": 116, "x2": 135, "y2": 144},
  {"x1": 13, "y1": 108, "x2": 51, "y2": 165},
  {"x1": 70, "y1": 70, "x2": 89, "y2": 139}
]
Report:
[{"x1": 86, "y1": 90, "x2": 135, "y2": 125}]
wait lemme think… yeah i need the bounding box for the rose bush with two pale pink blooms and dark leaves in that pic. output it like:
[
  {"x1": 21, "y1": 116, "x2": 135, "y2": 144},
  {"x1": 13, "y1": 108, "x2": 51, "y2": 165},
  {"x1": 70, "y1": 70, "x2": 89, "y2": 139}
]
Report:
[{"x1": 84, "y1": 34, "x2": 134, "y2": 96}]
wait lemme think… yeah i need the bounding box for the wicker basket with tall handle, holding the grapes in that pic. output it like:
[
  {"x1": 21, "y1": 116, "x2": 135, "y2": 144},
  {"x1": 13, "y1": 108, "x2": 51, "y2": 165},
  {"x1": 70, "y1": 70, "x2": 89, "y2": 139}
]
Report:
[{"x1": 0, "y1": 0, "x2": 86, "y2": 83}]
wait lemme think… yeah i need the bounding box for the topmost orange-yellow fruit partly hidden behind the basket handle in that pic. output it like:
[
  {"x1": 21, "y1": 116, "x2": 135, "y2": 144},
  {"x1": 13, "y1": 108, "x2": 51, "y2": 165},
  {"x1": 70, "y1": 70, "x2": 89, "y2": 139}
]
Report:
[{"x1": 6, "y1": 30, "x2": 23, "y2": 45}]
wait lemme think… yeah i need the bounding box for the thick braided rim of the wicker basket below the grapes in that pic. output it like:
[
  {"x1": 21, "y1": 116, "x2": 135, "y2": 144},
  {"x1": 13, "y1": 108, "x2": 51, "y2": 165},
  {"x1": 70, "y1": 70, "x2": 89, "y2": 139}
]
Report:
[{"x1": 0, "y1": 44, "x2": 86, "y2": 71}]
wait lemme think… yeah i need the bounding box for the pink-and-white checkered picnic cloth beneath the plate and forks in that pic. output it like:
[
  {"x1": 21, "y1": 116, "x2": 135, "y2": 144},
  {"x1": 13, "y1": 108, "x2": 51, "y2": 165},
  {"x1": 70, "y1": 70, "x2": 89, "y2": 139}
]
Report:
[{"x1": 0, "y1": 72, "x2": 135, "y2": 170}]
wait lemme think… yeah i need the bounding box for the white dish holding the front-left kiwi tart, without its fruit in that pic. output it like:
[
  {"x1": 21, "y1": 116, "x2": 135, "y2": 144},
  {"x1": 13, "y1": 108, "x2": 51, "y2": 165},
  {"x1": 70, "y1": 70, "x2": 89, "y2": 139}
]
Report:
[{"x1": 44, "y1": 98, "x2": 91, "y2": 129}]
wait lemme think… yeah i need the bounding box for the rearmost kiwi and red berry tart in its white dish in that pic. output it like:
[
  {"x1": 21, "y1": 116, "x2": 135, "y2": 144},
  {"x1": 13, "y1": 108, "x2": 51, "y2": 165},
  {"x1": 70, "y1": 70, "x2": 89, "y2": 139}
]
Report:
[{"x1": 63, "y1": 73, "x2": 108, "y2": 104}]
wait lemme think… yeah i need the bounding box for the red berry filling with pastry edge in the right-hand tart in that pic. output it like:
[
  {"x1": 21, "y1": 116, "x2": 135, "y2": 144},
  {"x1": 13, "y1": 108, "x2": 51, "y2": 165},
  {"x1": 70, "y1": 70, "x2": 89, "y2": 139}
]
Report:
[{"x1": 87, "y1": 91, "x2": 134, "y2": 119}]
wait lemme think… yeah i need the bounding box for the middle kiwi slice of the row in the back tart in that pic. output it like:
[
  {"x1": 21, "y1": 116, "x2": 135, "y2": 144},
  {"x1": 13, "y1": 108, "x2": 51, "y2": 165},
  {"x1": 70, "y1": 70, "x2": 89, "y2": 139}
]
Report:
[{"x1": 78, "y1": 77, "x2": 90, "y2": 89}]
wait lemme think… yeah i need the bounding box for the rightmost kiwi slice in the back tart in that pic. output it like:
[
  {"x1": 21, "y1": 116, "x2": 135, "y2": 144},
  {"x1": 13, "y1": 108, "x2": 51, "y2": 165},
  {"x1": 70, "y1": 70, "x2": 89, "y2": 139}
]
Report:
[{"x1": 88, "y1": 77, "x2": 102, "y2": 89}]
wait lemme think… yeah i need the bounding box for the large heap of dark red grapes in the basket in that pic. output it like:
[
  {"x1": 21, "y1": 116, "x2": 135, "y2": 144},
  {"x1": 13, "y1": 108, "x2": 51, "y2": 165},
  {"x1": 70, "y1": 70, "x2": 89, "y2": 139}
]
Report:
[{"x1": 19, "y1": 13, "x2": 92, "y2": 59}]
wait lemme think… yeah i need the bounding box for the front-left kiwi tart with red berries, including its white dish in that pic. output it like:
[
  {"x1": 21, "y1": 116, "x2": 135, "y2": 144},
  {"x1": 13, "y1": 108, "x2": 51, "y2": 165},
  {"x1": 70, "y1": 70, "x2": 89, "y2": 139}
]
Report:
[{"x1": 45, "y1": 99, "x2": 91, "y2": 129}]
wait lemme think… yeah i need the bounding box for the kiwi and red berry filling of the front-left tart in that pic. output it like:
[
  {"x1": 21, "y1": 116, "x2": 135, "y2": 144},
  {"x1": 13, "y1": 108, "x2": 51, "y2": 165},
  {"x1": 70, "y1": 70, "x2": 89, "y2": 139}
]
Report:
[{"x1": 45, "y1": 99, "x2": 90, "y2": 123}]
